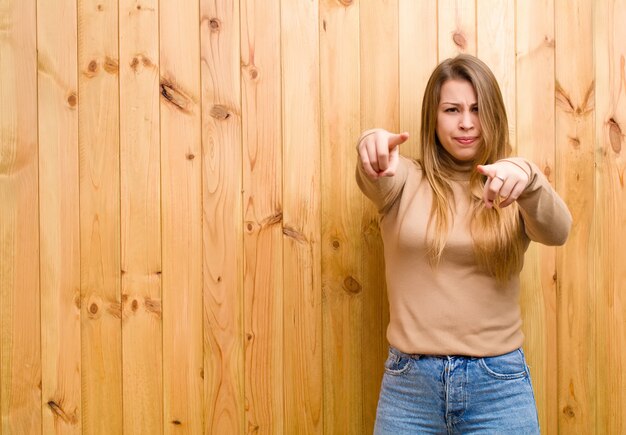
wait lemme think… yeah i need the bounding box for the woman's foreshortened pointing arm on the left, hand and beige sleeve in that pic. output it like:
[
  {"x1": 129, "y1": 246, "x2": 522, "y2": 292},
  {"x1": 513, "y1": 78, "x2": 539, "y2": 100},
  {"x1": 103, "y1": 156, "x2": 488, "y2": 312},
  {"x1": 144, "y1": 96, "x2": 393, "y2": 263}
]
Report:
[{"x1": 356, "y1": 129, "x2": 409, "y2": 213}]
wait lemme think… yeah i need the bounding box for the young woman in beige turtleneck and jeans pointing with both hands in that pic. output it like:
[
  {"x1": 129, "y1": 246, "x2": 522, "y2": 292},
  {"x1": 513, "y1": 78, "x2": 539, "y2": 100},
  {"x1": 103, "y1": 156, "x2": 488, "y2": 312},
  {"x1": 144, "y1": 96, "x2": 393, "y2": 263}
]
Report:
[{"x1": 356, "y1": 55, "x2": 571, "y2": 435}]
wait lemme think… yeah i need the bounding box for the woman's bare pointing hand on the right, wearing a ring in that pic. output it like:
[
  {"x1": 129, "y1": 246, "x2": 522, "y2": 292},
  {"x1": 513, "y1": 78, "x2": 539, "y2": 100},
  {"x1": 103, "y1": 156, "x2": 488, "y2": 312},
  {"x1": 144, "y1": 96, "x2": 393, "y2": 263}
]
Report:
[{"x1": 476, "y1": 164, "x2": 529, "y2": 208}]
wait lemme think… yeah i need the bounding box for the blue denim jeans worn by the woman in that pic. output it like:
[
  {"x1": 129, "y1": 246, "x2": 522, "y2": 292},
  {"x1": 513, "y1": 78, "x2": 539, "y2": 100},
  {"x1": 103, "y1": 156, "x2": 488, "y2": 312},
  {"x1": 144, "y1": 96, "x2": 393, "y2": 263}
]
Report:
[{"x1": 374, "y1": 348, "x2": 539, "y2": 435}]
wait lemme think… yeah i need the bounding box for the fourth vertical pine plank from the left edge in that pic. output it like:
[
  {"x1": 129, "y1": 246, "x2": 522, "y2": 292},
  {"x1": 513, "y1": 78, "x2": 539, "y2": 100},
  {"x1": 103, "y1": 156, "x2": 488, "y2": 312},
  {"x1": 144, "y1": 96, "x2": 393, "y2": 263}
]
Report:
[{"x1": 119, "y1": 0, "x2": 163, "y2": 434}]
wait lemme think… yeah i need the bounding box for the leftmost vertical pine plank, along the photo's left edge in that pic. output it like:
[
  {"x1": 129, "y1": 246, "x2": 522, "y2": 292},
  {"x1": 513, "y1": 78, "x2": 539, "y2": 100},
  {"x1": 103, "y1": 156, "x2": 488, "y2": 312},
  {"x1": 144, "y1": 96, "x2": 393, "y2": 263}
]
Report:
[{"x1": 0, "y1": 0, "x2": 41, "y2": 434}]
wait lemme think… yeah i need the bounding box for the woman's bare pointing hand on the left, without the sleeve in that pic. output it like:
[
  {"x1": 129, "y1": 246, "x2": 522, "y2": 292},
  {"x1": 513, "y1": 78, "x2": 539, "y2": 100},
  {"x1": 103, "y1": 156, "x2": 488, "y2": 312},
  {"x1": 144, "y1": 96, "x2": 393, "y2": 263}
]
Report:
[{"x1": 356, "y1": 128, "x2": 409, "y2": 179}]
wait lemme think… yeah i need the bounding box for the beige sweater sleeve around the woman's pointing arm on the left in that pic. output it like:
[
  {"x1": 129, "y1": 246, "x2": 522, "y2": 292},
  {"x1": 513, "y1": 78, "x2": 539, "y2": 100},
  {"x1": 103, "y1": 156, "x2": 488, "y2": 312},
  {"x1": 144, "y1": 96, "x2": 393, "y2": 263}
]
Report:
[{"x1": 356, "y1": 156, "x2": 411, "y2": 214}]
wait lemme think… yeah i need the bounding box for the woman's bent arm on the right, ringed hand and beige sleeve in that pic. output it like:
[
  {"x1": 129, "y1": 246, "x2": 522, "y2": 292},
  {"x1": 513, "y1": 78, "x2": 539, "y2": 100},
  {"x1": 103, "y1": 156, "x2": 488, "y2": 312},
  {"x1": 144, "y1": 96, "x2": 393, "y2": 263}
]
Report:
[{"x1": 478, "y1": 157, "x2": 572, "y2": 246}]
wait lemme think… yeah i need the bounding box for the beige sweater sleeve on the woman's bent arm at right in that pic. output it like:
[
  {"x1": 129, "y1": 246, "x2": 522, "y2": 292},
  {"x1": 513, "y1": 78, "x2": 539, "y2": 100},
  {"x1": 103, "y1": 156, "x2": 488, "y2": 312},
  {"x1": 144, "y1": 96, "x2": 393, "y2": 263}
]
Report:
[{"x1": 504, "y1": 157, "x2": 572, "y2": 246}]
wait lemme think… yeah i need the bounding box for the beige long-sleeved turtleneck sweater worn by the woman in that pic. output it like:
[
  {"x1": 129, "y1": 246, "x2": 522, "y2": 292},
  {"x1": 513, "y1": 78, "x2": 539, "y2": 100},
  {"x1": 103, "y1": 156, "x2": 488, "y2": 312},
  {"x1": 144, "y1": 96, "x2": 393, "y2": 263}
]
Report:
[{"x1": 356, "y1": 157, "x2": 572, "y2": 357}]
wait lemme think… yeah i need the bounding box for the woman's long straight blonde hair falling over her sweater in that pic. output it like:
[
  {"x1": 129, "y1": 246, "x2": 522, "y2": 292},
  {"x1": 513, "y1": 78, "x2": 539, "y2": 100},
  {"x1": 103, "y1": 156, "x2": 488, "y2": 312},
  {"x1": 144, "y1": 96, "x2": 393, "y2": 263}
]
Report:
[{"x1": 420, "y1": 54, "x2": 524, "y2": 282}]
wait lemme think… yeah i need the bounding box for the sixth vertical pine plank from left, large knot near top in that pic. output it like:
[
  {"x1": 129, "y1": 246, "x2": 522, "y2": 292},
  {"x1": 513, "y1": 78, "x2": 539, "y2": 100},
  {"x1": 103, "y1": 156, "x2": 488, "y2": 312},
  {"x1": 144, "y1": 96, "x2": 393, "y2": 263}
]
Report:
[{"x1": 200, "y1": 0, "x2": 245, "y2": 434}]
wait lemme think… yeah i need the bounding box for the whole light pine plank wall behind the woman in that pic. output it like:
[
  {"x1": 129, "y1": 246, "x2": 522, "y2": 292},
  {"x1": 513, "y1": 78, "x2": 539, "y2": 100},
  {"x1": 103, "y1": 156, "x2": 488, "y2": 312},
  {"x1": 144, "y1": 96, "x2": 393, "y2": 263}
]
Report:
[{"x1": 0, "y1": 0, "x2": 626, "y2": 435}]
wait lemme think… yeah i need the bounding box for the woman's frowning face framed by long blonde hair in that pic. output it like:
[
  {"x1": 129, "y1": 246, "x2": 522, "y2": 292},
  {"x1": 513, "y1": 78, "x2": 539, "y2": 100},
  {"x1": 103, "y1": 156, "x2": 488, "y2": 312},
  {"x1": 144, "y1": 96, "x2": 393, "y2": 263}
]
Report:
[{"x1": 436, "y1": 79, "x2": 482, "y2": 162}]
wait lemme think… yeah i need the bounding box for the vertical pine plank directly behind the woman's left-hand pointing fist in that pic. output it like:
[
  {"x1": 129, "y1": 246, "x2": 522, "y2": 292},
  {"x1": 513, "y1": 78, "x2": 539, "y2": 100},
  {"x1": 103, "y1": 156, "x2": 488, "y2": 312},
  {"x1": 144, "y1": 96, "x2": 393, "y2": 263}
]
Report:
[{"x1": 359, "y1": 0, "x2": 400, "y2": 433}]
